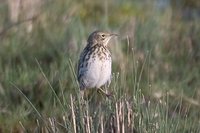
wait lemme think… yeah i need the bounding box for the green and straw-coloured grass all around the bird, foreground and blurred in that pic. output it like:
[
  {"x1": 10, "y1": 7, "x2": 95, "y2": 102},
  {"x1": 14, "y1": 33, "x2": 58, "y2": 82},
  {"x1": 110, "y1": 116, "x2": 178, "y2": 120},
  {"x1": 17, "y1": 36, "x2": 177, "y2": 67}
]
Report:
[{"x1": 0, "y1": 0, "x2": 200, "y2": 133}]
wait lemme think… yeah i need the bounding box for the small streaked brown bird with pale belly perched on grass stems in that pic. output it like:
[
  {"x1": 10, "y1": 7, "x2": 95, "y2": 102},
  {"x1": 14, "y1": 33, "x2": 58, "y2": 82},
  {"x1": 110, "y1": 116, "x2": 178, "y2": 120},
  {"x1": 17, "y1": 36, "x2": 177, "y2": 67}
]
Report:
[{"x1": 77, "y1": 31, "x2": 117, "y2": 97}]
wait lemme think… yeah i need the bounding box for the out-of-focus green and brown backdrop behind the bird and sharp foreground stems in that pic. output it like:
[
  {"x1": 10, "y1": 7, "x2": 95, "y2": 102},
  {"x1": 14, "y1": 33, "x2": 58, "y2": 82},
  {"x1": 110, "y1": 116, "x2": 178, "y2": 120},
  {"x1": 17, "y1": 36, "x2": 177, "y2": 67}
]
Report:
[{"x1": 0, "y1": 0, "x2": 200, "y2": 132}]
